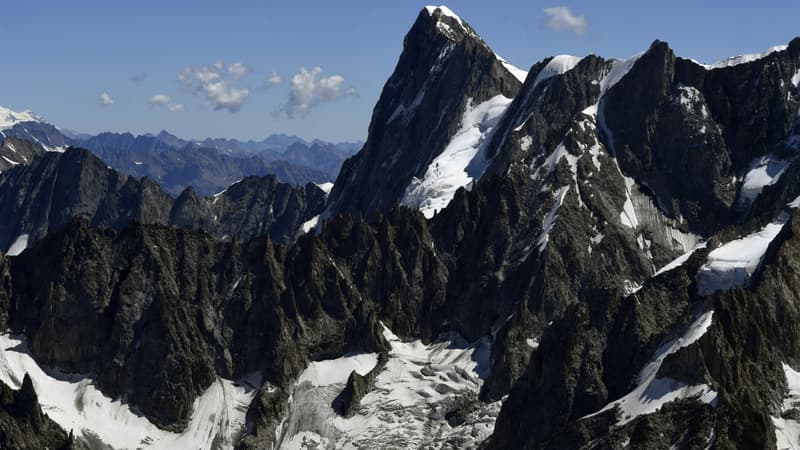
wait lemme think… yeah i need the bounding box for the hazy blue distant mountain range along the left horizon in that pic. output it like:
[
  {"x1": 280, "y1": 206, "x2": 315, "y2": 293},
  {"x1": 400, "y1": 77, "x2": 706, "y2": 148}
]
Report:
[{"x1": 0, "y1": 107, "x2": 362, "y2": 195}]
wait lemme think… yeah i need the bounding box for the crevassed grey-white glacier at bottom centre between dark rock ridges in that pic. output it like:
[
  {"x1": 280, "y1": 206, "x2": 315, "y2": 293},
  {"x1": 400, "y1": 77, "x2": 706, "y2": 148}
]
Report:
[{"x1": 278, "y1": 328, "x2": 501, "y2": 449}]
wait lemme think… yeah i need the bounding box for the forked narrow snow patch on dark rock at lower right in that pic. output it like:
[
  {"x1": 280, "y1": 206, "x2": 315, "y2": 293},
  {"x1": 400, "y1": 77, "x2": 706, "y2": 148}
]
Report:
[{"x1": 583, "y1": 311, "x2": 717, "y2": 425}]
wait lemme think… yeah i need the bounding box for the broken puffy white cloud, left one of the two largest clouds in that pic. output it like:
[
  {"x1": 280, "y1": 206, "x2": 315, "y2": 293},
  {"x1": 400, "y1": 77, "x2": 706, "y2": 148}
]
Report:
[{"x1": 178, "y1": 61, "x2": 250, "y2": 113}]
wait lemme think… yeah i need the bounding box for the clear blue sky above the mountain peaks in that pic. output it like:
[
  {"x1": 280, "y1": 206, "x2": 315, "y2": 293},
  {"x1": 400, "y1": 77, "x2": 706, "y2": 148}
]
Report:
[{"x1": 0, "y1": 0, "x2": 800, "y2": 141}]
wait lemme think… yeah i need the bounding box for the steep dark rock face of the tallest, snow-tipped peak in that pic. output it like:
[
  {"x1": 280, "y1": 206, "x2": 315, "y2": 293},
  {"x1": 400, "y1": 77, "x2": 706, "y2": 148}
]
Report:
[{"x1": 331, "y1": 9, "x2": 520, "y2": 214}]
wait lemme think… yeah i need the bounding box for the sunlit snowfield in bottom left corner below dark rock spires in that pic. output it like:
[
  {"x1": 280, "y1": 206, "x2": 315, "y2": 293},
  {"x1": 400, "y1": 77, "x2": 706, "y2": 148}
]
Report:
[{"x1": 0, "y1": 334, "x2": 261, "y2": 449}]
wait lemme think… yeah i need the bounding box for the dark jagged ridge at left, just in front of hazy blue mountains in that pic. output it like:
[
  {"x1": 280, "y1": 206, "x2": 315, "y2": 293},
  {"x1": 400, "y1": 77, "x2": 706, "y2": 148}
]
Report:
[{"x1": 0, "y1": 149, "x2": 325, "y2": 249}]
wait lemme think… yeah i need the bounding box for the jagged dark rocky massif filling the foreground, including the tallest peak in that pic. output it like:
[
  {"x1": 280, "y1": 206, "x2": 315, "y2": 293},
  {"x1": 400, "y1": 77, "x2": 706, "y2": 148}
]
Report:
[{"x1": 0, "y1": 8, "x2": 800, "y2": 449}]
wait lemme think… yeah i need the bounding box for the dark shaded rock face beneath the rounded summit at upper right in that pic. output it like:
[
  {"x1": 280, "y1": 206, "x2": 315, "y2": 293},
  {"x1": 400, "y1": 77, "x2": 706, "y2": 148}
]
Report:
[{"x1": 601, "y1": 42, "x2": 800, "y2": 234}]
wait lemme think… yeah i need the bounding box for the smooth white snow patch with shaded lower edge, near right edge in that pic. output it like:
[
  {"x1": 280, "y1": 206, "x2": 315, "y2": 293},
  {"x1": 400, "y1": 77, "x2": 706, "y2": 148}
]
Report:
[{"x1": 697, "y1": 213, "x2": 789, "y2": 295}]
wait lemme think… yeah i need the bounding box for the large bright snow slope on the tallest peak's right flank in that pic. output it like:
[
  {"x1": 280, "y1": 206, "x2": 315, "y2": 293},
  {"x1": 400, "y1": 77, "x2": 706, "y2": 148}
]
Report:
[{"x1": 401, "y1": 95, "x2": 512, "y2": 218}]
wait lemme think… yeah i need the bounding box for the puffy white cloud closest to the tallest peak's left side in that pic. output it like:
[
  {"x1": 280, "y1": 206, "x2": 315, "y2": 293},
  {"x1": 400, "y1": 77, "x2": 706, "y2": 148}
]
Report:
[{"x1": 283, "y1": 67, "x2": 358, "y2": 118}]
